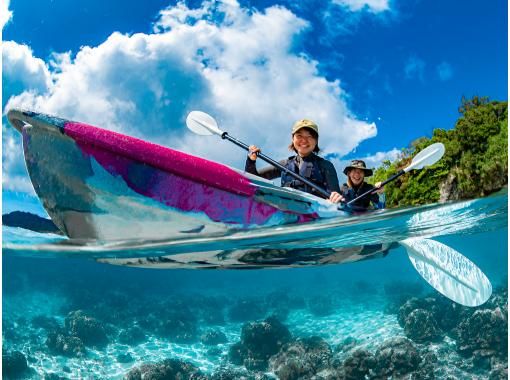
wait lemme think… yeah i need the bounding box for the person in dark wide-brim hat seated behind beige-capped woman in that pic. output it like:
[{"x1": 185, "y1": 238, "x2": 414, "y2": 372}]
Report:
[{"x1": 340, "y1": 160, "x2": 384, "y2": 211}]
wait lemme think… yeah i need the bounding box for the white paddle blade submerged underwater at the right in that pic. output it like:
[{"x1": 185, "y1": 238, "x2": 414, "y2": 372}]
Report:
[{"x1": 399, "y1": 238, "x2": 492, "y2": 307}]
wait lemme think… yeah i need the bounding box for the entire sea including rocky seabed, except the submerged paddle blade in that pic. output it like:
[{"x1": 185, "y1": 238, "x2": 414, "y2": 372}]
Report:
[{"x1": 2, "y1": 192, "x2": 508, "y2": 379}]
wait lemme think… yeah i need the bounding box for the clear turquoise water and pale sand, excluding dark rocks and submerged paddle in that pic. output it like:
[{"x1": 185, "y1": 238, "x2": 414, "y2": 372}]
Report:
[{"x1": 2, "y1": 193, "x2": 508, "y2": 379}]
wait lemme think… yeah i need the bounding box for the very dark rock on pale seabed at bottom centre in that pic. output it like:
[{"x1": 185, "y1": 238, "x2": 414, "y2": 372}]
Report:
[{"x1": 229, "y1": 317, "x2": 291, "y2": 371}]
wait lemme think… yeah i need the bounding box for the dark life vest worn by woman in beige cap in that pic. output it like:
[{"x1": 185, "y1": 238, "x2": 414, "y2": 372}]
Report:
[{"x1": 281, "y1": 154, "x2": 328, "y2": 198}]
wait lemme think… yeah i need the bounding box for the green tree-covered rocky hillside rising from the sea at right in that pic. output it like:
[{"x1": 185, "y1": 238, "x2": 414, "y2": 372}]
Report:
[{"x1": 372, "y1": 96, "x2": 508, "y2": 207}]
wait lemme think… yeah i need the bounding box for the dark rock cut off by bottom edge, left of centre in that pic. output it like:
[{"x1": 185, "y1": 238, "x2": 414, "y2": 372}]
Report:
[{"x1": 125, "y1": 359, "x2": 207, "y2": 380}]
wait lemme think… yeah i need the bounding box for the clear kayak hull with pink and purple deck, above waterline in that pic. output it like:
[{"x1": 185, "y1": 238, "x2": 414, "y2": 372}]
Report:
[{"x1": 8, "y1": 110, "x2": 341, "y2": 240}]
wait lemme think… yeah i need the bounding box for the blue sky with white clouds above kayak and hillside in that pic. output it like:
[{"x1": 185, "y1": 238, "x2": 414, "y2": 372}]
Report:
[{"x1": 2, "y1": 0, "x2": 508, "y2": 202}]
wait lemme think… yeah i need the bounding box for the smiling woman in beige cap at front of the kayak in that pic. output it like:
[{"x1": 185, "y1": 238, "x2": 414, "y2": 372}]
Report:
[{"x1": 245, "y1": 119, "x2": 342, "y2": 203}]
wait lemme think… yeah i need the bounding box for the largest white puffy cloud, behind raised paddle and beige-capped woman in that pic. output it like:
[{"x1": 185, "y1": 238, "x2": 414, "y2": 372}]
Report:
[{"x1": 6, "y1": 1, "x2": 377, "y2": 193}]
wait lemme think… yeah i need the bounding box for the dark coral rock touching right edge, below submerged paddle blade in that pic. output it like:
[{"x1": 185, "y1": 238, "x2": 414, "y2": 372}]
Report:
[{"x1": 457, "y1": 307, "x2": 508, "y2": 356}]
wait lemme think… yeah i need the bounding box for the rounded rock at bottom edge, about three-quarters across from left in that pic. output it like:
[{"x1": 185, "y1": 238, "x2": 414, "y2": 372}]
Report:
[{"x1": 374, "y1": 337, "x2": 421, "y2": 378}]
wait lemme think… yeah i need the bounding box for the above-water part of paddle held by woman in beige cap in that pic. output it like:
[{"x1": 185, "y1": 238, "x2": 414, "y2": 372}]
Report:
[{"x1": 186, "y1": 111, "x2": 330, "y2": 198}]
